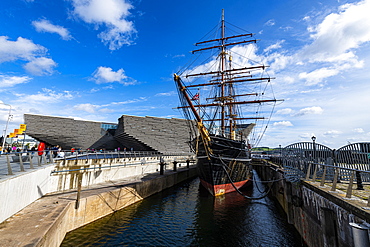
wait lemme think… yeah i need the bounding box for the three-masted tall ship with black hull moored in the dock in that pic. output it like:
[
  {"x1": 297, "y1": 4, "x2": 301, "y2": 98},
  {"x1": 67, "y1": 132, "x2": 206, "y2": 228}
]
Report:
[{"x1": 174, "y1": 10, "x2": 278, "y2": 196}]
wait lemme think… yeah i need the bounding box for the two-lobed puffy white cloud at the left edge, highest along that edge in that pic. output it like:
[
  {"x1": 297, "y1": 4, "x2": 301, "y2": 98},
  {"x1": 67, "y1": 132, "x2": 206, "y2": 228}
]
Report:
[{"x1": 0, "y1": 36, "x2": 57, "y2": 75}]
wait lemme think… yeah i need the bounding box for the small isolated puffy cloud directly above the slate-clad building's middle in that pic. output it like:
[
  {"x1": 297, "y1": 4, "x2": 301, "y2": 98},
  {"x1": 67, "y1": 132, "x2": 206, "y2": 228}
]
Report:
[{"x1": 92, "y1": 66, "x2": 132, "y2": 85}]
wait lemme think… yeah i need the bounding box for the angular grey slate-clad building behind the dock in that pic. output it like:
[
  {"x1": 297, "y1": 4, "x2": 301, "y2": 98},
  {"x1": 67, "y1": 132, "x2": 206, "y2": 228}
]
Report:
[{"x1": 24, "y1": 114, "x2": 192, "y2": 153}]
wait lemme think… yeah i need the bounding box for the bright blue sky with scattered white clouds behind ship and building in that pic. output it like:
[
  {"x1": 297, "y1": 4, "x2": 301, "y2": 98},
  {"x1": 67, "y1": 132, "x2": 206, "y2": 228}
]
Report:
[{"x1": 0, "y1": 0, "x2": 370, "y2": 148}]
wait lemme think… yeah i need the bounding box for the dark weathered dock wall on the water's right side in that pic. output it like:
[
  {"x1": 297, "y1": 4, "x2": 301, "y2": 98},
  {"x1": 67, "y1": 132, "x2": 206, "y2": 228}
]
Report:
[{"x1": 255, "y1": 162, "x2": 370, "y2": 247}]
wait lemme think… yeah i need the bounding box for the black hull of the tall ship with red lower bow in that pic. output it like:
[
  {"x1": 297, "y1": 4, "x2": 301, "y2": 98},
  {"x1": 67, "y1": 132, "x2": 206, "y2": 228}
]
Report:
[{"x1": 197, "y1": 136, "x2": 251, "y2": 196}]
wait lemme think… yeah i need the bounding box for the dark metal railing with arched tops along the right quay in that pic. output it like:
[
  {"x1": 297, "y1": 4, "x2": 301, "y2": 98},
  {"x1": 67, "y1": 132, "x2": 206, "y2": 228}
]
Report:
[{"x1": 269, "y1": 142, "x2": 370, "y2": 207}]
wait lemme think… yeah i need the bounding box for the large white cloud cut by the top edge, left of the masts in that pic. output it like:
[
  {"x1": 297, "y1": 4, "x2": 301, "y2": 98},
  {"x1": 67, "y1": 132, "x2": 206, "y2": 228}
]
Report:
[{"x1": 72, "y1": 0, "x2": 136, "y2": 50}]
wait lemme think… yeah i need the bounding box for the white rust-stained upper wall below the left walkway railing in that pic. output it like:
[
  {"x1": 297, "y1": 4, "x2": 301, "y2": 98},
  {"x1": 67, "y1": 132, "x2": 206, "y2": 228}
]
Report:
[{"x1": 0, "y1": 156, "x2": 189, "y2": 223}]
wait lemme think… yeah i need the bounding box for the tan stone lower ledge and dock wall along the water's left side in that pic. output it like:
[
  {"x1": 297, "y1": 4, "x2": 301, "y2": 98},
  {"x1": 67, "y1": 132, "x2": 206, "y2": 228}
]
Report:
[{"x1": 0, "y1": 166, "x2": 197, "y2": 247}]
